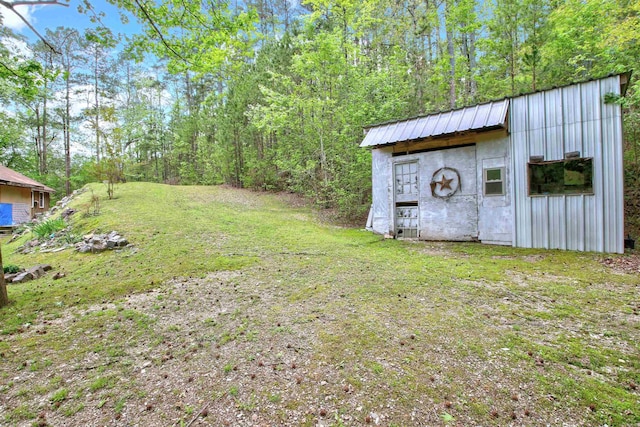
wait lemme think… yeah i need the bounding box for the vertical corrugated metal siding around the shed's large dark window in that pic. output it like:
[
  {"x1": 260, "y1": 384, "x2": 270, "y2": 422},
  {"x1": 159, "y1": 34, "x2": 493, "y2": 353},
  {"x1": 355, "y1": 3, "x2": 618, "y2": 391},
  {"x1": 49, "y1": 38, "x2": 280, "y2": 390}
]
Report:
[{"x1": 510, "y1": 76, "x2": 624, "y2": 252}]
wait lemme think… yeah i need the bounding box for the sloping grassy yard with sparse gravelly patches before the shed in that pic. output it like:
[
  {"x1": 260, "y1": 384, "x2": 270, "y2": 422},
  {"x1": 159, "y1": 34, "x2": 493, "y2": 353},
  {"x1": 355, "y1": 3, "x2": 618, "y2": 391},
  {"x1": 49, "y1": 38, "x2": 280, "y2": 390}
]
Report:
[{"x1": 0, "y1": 184, "x2": 640, "y2": 426}]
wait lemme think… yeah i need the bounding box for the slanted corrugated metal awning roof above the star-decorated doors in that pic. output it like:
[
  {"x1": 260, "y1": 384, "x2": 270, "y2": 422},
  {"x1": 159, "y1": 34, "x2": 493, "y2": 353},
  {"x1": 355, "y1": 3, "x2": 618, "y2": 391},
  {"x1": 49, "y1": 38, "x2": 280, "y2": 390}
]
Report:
[{"x1": 360, "y1": 98, "x2": 509, "y2": 147}]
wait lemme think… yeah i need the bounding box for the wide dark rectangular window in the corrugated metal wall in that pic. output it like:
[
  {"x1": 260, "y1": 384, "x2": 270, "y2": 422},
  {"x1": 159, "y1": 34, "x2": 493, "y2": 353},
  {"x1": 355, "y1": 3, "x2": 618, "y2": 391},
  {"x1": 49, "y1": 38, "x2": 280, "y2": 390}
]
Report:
[{"x1": 529, "y1": 158, "x2": 593, "y2": 196}]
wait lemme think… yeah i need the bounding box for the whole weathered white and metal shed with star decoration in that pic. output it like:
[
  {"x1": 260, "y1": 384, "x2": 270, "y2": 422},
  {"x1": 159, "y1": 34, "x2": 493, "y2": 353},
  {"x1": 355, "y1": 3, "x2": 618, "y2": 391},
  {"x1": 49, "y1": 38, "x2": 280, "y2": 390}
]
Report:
[{"x1": 360, "y1": 73, "x2": 630, "y2": 253}]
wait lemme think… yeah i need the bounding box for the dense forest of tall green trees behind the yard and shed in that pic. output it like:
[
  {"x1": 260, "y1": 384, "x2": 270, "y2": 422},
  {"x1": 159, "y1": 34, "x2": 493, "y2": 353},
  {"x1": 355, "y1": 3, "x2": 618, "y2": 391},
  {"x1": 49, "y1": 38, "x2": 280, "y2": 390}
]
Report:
[{"x1": 0, "y1": 0, "x2": 640, "y2": 227}]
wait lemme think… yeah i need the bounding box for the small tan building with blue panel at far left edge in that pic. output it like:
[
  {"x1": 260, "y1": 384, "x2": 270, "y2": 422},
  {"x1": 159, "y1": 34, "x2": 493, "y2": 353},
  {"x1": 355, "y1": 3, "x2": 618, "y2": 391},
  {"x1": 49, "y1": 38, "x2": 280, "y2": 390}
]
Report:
[{"x1": 0, "y1": 165, "x2": 55, "y2": 227}]
